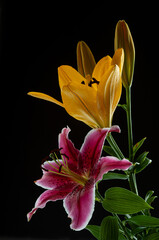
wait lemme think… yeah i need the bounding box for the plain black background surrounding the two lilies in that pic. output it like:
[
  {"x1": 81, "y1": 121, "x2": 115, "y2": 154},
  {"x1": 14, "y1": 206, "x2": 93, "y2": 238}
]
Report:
[{"x1": 0, "y1": 1, "x2": 159, "y2": 239}]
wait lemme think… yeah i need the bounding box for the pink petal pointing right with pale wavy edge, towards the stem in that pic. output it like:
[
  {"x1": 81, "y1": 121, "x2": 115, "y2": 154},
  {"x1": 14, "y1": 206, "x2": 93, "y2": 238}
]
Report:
[{"x1": 94, "y1": 156, "x2": 132, "y2": 182}]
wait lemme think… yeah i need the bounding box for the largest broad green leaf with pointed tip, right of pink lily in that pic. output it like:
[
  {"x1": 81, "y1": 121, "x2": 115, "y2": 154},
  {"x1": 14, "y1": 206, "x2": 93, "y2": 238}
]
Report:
[{"x1": 103, "y1": 187, "x2": 152, "y2": 214}]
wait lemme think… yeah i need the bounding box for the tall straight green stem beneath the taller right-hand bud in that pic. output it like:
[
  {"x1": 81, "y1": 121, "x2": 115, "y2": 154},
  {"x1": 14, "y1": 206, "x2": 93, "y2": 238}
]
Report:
[{"x1": 126, "y1": 87, "x2": 138, "y2": 195}]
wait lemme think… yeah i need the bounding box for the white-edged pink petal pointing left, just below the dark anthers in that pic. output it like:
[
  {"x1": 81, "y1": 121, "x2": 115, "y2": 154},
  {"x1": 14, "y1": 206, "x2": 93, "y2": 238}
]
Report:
[{"x1": 35, "y1": 160, "x2": 73, "y2": 189}]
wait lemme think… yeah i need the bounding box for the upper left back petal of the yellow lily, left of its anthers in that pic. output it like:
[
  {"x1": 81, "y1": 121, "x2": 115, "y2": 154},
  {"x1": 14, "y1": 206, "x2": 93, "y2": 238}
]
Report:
[{"x1": 58, "y1": 65, "x2": 85, "y2": 89}]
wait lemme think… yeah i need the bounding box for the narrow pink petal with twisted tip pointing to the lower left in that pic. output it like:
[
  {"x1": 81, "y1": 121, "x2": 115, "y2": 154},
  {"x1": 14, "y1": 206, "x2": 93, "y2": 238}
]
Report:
[{"x1": 27, "y1": 184, "x2": 74, "y2": 221}]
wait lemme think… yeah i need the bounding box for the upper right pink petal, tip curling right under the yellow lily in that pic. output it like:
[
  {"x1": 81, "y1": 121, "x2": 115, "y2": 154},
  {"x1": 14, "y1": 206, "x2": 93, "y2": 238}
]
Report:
[{"x1": 78, "y1": 126, "x2": 120, "y2": 172}]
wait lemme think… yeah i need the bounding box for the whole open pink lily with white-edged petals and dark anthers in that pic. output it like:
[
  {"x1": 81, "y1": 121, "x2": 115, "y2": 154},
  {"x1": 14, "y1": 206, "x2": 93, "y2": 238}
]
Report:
[{"x1": 27, "y1": 126, "x2": 131, "y2": 230}]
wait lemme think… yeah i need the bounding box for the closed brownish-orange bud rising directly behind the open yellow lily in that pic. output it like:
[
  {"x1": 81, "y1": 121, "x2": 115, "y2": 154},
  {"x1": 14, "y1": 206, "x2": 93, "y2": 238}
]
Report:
[{"x1": 76, "y1": 41, "x2": 96, "y2": 77}]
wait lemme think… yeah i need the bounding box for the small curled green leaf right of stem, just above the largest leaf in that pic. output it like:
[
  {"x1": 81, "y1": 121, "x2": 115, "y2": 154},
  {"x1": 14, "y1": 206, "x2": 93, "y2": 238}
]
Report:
[{"x1": 134, "y1": 152, "x2": 152, "y2": 173}]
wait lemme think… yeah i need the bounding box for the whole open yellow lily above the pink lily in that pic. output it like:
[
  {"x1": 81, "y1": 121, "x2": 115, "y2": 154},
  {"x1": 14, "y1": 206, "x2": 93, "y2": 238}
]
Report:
[{"x1": 28, "y1": 45, "x2": 124, "y2": 128}]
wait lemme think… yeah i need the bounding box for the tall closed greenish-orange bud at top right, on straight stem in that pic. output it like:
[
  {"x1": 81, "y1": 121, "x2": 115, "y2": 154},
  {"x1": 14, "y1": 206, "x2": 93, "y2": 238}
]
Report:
[{"x1": 114, "y1": 20, "x2": 135, "y2": 88}]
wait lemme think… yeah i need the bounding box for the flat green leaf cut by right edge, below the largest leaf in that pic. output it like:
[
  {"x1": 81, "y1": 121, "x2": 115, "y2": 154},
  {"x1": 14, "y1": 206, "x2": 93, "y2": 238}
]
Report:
[{"x1": 126, "y1": 215, "x2": 159, "y2": 227}]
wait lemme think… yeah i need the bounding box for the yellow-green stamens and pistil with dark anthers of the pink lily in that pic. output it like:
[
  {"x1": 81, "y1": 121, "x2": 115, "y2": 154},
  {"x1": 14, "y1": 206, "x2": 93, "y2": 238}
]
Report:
[{"x1": 42, "y1": 150, "x2": 88, "y2": 186}]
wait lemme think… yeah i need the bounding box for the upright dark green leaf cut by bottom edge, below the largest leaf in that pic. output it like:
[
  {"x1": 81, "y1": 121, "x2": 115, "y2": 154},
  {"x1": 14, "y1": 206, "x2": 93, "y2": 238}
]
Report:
[{"x1": 99, "y1": 216, "x2": 119, "y2": 240}]
